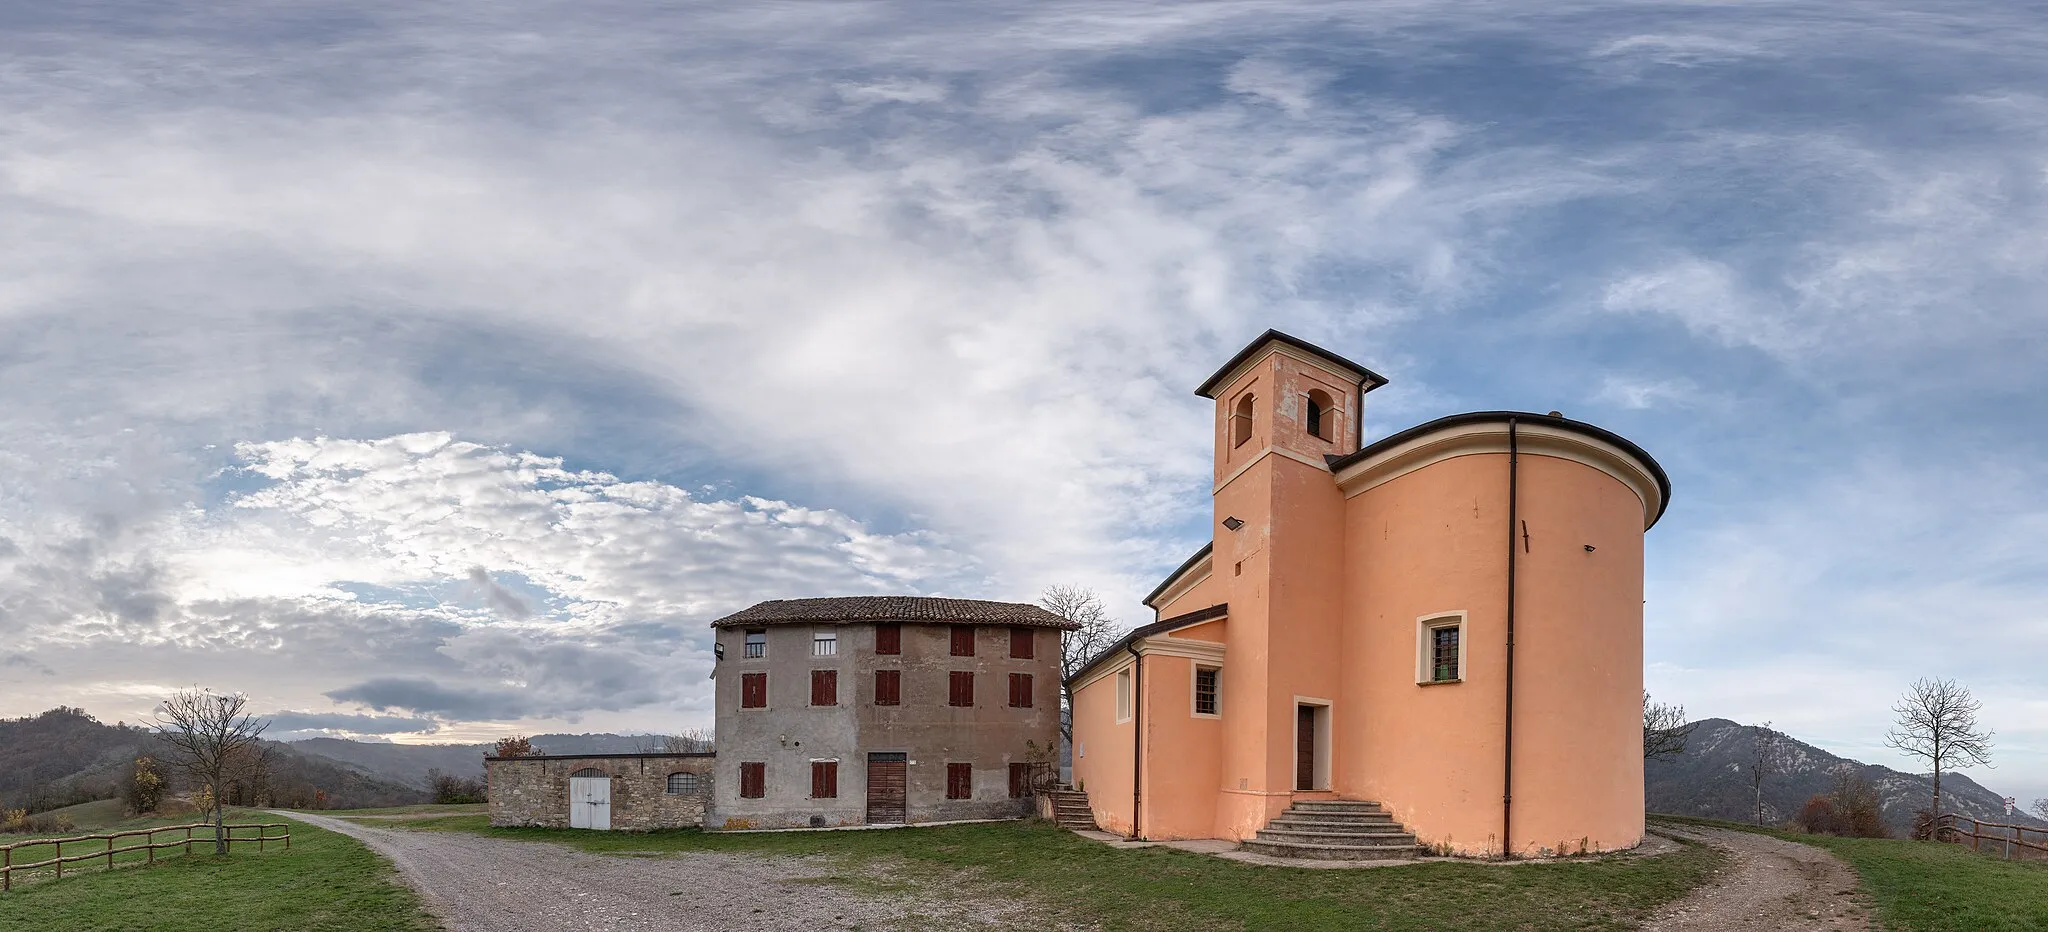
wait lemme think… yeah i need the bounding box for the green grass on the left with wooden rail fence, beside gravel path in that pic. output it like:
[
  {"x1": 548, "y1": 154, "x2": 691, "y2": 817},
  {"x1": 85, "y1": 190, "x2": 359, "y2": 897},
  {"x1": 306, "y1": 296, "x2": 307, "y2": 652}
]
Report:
[{"x1": 0, "y1": 813, "x2": 438, "y2": 932}]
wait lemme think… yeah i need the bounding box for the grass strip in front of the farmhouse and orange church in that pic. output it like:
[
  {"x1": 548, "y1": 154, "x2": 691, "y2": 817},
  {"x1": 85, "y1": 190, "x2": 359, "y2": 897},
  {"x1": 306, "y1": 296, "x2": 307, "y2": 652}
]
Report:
[{"x1": 389, "y1": 815, "x2": 1722, "y2": 930}]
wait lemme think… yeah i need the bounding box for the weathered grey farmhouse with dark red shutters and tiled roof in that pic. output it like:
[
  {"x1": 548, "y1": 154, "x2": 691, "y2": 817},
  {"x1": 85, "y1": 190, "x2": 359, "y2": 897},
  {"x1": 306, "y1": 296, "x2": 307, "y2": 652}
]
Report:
[{"x1": 713, "y1": 596, "x2": 1073, "y2": 828}]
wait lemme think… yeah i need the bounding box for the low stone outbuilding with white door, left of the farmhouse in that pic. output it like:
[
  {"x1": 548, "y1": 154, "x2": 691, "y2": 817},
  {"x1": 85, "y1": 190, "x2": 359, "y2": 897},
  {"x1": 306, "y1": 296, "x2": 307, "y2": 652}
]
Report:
[{"x1": 483, "y1": 752, "x2": 715, "y2": 832}]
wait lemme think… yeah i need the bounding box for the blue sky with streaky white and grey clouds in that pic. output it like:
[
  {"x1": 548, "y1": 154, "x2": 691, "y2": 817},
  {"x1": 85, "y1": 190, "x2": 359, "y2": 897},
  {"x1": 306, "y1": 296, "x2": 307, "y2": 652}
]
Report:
[{"x1": 0, "y1": 0, "x2": 2048, "y2": 799}]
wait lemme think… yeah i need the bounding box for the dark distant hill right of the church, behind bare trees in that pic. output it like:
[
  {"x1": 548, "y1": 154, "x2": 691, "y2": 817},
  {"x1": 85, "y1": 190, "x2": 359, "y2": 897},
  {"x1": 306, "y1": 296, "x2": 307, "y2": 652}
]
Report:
[{"x1": 1642, "y1": 719, "x2": 2048, "y2": 838}]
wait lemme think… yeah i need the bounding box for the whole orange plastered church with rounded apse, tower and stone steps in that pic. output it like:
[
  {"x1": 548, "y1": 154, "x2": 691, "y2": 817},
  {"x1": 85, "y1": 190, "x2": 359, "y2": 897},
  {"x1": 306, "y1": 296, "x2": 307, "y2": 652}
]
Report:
[{"x1": 1073, "y1": 332, "x2": 1671, "y2": 858}]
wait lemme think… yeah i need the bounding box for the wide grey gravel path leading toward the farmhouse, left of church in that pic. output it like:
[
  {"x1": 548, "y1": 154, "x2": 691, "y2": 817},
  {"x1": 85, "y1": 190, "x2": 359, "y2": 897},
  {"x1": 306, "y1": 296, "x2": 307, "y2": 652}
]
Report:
[{"x1": 274, "y1": 813, "x2": 1047, "y2": 932}]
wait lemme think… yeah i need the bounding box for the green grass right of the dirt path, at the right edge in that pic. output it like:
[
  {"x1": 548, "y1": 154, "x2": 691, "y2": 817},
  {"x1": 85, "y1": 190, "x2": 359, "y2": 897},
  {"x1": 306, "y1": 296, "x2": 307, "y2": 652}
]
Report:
[{"x1": 1653, "y1": 815, "x2": 2048, "y2": 932}]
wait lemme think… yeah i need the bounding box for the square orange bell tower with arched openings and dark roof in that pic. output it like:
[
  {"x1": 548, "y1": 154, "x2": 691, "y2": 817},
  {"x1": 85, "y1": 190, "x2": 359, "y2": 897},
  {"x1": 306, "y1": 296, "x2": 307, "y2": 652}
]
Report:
[{"x1": 1196, "y1": 330, "x2": 1386, "y2": 838}]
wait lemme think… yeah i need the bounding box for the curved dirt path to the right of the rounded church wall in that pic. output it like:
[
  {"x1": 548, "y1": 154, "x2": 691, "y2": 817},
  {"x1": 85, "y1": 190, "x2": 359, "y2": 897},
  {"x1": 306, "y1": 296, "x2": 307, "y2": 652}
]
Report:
[{"x1": 1642, "y1": 823, "x2": 1870, "y2": 932}]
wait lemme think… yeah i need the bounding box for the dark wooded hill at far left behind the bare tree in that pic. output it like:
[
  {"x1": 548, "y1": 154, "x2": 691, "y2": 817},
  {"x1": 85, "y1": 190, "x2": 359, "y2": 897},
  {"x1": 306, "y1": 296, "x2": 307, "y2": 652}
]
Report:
[{"x1": 0, "y1": 707, "x2": 426, "y2": 811}]
